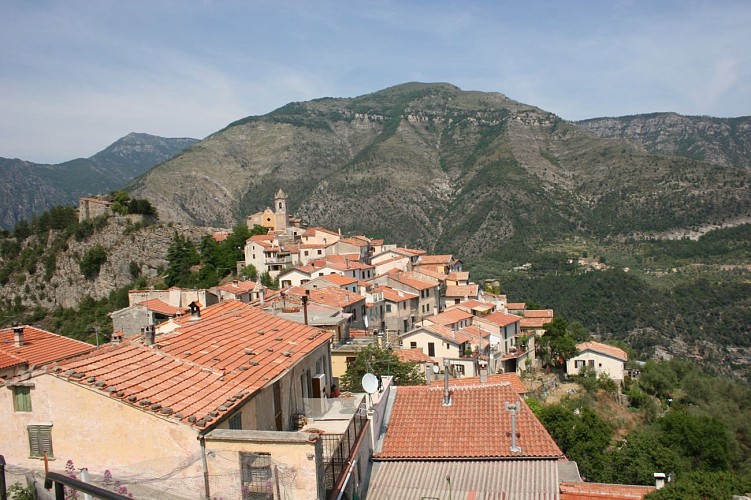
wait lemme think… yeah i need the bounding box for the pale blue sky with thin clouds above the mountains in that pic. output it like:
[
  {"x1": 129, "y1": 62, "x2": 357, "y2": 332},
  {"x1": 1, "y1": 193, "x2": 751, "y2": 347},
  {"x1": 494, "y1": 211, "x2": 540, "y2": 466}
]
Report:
[{"x1": 0, "y1": 0, "x2": 751, "y2": 163}]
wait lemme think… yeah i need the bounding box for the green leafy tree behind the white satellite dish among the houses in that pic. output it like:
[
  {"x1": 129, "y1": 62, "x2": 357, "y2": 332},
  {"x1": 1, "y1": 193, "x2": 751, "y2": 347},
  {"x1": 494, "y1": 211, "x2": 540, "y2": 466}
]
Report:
[{"x1": 339, "y1": 345, "x2": 425, "y2": 392}]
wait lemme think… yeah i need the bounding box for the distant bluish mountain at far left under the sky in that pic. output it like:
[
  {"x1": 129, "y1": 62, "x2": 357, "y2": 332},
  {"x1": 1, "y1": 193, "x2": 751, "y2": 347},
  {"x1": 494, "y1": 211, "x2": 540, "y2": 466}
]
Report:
[{"x1": 0, "y1": 133, "x2": 198, "y2": 229}]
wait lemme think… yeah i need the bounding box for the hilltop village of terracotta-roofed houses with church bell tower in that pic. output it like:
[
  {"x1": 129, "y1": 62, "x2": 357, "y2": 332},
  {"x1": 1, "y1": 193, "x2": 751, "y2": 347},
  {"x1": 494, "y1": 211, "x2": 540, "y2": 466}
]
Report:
[{"x1": 0, "y1": 190, "x2": 648, "y2": 499}]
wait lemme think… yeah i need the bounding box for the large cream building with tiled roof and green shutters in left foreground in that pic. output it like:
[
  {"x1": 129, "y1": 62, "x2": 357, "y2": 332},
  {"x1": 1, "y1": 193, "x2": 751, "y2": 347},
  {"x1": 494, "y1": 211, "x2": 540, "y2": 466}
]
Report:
[{"x1": 0, "y1": 300, "x2": 371, "y2": 498}]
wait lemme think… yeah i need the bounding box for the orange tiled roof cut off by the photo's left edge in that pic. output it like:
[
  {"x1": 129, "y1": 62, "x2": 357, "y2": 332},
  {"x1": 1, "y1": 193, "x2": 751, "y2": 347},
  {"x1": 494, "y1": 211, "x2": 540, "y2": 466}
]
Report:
[{"x1": 0, "y1": 325, "x2": 95, "y2": 368}]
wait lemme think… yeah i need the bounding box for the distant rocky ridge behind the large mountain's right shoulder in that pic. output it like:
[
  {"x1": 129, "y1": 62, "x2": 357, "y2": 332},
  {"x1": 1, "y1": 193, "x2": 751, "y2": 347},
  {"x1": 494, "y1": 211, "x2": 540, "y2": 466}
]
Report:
[{"x1": 577, "y1": 113, "x2": 751, "y2": 168}]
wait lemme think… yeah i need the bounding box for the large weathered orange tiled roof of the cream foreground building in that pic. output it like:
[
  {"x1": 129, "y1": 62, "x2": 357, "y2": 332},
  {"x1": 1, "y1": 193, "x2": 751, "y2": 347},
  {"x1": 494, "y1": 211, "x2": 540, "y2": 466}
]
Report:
[{"x1": 47, "y1": 300, "x2": 331, "y2": 428}]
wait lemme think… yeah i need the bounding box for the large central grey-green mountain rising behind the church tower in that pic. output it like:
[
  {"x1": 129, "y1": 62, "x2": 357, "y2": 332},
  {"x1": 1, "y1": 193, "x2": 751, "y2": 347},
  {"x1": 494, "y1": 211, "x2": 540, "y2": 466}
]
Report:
[{"x1": 129, "y1": 83, "x2": 751, "y2": 258}]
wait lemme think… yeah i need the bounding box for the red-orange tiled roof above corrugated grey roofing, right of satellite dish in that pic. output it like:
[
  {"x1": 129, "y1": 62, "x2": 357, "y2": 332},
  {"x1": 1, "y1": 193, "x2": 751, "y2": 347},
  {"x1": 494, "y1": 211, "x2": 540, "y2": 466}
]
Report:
[{"x1": 376, "y1": 384, "x2": 563, "y2": 459}]
